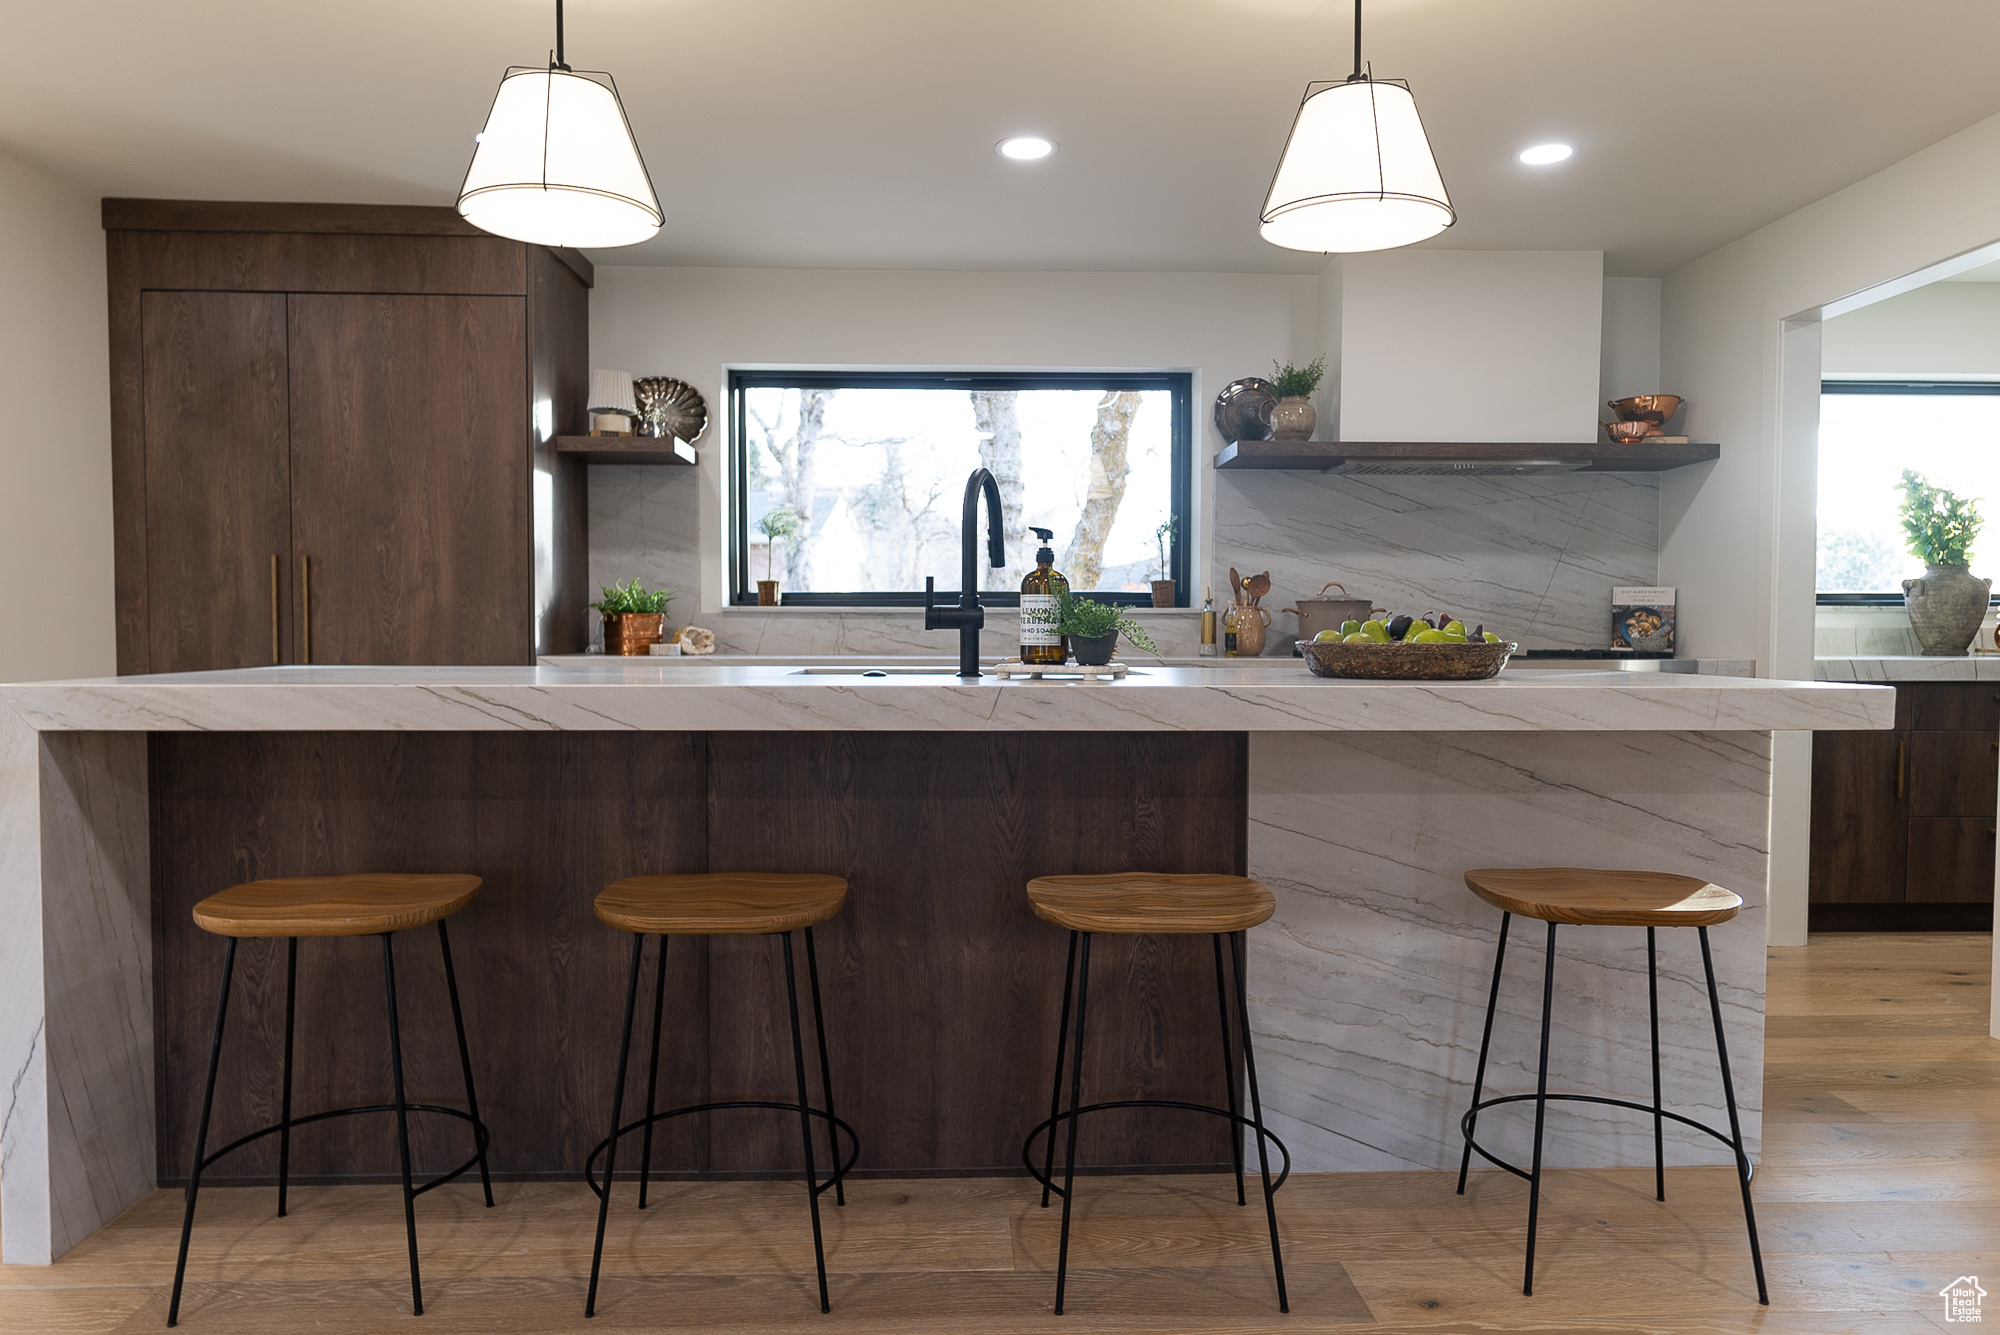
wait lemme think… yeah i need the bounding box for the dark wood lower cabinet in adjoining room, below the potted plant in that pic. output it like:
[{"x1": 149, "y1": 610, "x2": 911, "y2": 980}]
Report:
[{"x1": 1810, "y1": 681, "x2": 2000, "y2": 931}]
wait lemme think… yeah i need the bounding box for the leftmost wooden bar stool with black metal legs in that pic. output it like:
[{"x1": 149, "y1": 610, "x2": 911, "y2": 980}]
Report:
[{"x1": 166, "y1": 873, "x2": 494, "y2": 1325}]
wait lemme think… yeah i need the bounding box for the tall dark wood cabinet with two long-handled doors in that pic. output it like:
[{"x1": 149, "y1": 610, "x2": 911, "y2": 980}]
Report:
[{"x1": 104, "y1": 200, "x2": 590, "y2": 673}]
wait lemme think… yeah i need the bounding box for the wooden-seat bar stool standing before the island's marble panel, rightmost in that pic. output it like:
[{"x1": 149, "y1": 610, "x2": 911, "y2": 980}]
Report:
[{"x1": 1458, "y1": 867, "x2": 1770, "y2": 1307}]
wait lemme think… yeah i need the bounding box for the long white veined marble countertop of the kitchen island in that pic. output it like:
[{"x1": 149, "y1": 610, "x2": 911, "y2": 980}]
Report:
[{"x1": 0, "y1": 660, "x2": 1894, "y2": 731}]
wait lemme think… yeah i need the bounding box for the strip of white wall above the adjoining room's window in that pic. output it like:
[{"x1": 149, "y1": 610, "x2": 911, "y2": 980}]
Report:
[{"x1": 1820, "y1": 282, "x2": 2000, "y2": 380}]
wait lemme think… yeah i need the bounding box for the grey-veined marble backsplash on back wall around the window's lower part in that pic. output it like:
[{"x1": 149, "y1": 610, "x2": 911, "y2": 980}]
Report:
[{"x1": 590, "y1": 466, "x2": 1664, "y2": 654}]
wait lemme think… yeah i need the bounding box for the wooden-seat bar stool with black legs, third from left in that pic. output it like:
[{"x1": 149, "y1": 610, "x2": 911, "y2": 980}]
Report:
[{"x1": 1020, "y1": 871, "x2": 1292, "y2": 1317}]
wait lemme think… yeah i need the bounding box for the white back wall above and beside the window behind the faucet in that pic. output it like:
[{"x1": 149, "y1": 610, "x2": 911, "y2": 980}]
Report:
[{"x1": 590, "y1": 266, "x2": 1320, "y2": 616}]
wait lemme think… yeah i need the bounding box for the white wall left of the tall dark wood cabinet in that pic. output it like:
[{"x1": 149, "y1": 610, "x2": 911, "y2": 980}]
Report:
[{"x1": 0, "y1": 152, "x2": 116, "y2": 681}]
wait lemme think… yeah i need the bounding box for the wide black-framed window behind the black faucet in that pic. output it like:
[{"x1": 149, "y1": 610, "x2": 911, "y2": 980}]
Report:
[{"x1": 730, "y1": 370, "x2": 1192, "y2": 608}]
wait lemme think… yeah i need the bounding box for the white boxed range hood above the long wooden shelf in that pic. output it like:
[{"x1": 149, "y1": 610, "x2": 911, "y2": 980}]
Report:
[{"x1": 1340, "y1": 250, "x2": 1604, "y2": 442}]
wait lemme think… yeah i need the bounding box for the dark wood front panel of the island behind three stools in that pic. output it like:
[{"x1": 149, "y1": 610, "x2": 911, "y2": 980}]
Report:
[{"x1": 150, "y1": 731, "x2": 1248, "y2": 1183}]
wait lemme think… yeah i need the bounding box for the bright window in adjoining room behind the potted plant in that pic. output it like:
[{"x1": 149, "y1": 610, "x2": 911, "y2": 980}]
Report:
[{"x1": 1818, "y1": 380, "x2": 2000, "y2": 604}]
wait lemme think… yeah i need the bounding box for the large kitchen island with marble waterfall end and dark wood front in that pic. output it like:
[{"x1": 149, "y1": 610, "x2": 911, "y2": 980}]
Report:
[{"x1": 0, "y1": 660, "x2": 1894, "y2": 1261}]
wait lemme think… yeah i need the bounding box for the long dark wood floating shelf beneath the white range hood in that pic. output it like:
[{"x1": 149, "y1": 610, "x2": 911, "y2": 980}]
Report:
[{"x1": 1216, "y1": 440, "x2": 1722, "y2": 476}]
